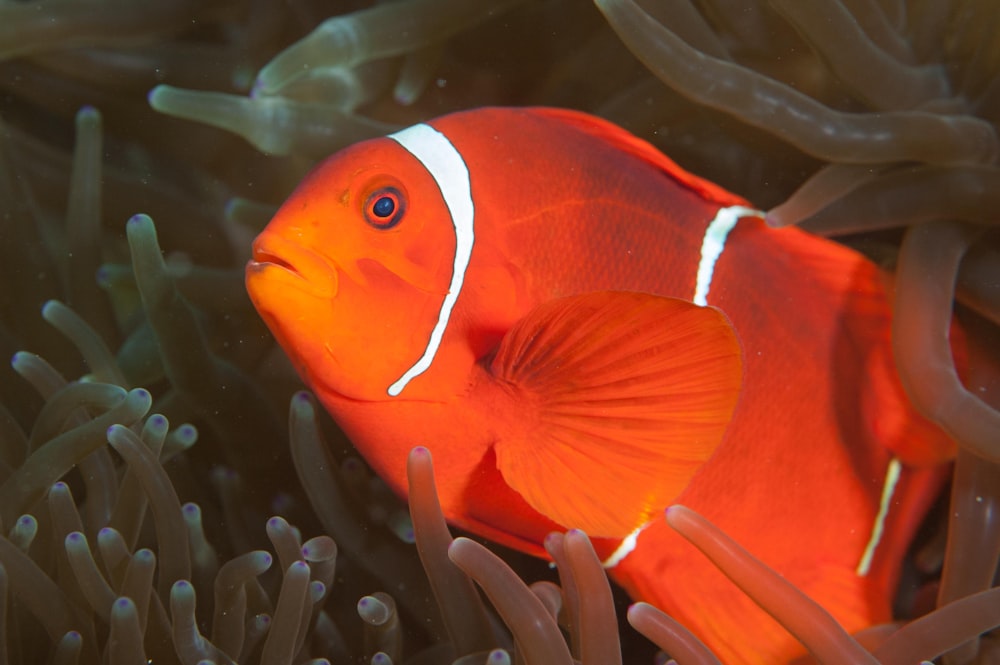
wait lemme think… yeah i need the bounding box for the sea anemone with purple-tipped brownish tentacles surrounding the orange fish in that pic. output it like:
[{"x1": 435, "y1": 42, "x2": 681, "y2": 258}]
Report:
[{"x1": 0, "y1": 0, "x2": 1000, "y2": 664}]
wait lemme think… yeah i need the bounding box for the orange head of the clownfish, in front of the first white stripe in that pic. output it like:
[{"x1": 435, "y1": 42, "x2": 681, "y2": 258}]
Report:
[{"x1": 246, "y1": 138, "x2": 457, "y2": 400}]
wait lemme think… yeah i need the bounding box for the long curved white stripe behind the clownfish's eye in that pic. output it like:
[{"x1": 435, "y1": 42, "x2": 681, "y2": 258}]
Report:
[{"x1": 388, "y1": 124, "x2": 474, "y2": 397}]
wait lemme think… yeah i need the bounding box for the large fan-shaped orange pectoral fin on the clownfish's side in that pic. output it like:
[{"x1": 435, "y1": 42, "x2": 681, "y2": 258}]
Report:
[{"x1": 490, "y1": 291, "x2": 742, "y2": 538}]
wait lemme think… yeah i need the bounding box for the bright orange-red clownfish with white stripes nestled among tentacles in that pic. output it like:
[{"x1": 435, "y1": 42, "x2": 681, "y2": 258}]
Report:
[{"x1": 246, "y1": 108, "x2": 954, "y2": 663}]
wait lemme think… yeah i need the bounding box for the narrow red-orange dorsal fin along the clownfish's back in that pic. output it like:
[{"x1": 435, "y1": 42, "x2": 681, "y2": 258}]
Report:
[{"x1": 525, "y1": 106, "x2": 752, "y2": 207}]
